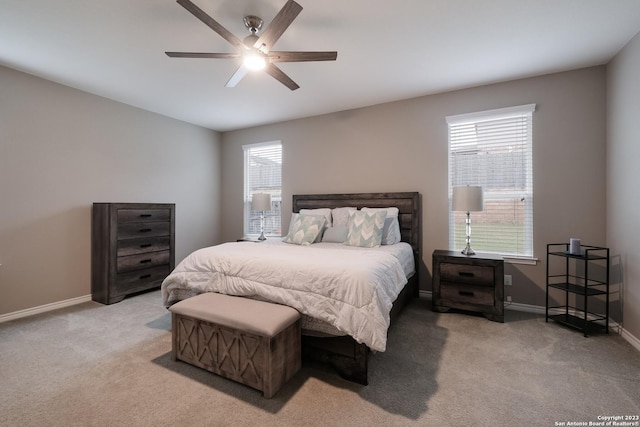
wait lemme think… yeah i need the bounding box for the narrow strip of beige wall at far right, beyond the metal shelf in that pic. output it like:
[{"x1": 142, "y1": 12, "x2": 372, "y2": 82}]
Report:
[{"x1": 607, "y1": 33, "x2": 640, "y2": 339}]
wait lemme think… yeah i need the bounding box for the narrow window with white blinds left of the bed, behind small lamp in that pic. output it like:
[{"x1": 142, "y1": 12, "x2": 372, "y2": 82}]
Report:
[{"x1": 242, "y1": 141, "x2": 282, "y2": 236}]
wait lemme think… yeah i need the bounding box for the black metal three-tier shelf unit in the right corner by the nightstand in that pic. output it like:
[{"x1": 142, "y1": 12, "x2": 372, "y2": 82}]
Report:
[{"x1": 545, "y1": 243, "x2": 609, "y2": 337}]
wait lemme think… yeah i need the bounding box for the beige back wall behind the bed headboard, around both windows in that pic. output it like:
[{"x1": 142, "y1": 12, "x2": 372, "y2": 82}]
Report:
[{"x1": 221, "y1": 67, "x2": 606, "y2": 312}]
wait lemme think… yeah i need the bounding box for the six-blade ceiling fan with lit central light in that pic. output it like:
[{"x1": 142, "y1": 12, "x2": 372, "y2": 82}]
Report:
[{"x1": 165, "y1": 0, "x2": 338, "y2": 90}]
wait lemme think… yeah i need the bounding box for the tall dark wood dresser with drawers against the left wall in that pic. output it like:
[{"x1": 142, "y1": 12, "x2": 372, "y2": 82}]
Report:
[{"x1": 91, "y1": 203, "x2": 175, "y2": 304}]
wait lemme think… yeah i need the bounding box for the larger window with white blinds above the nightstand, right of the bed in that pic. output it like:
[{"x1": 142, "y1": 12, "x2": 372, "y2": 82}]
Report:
[{"x1": 447, "y1": 104, "x2": 535, "y2": 259}]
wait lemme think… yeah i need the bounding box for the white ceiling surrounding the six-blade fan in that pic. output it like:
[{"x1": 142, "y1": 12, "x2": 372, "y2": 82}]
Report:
[{"x1": 0, "y1": 0, "x2": 640, "y2": 131}]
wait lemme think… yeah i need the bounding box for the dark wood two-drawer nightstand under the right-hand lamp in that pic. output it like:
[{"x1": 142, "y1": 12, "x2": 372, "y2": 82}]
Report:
[{"x1": 432, "y1": 250, "x2": 504, "y2": 322}]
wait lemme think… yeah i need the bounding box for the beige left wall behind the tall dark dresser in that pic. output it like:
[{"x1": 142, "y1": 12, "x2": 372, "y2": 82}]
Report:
[{"x1": 0, "y1": 67, "x2": 221, "y2": 314}]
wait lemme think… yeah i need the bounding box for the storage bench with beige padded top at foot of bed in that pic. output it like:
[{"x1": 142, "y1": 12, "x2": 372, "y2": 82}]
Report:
[{"x1": 169, "y1": 293, "x2": 301, "y2": 398}]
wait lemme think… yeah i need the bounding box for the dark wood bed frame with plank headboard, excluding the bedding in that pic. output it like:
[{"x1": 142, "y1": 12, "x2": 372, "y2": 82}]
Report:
[{"x1": 292, "y1": 192, "x2": 422, "y2": 385}]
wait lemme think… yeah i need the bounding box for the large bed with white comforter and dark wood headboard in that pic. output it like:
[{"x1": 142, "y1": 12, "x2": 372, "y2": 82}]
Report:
[{"x1": 162, "y1": 192, "x2": 421, "y2": 384}]
